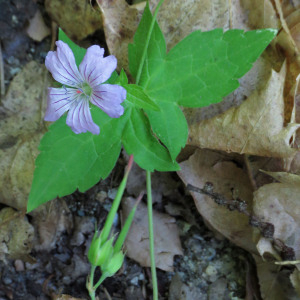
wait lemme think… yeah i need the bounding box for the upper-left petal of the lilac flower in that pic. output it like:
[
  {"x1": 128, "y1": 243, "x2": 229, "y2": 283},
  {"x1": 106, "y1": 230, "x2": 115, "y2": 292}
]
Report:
[{"x1": 45, "y1": 41, "x2": 83, "y2": 87}]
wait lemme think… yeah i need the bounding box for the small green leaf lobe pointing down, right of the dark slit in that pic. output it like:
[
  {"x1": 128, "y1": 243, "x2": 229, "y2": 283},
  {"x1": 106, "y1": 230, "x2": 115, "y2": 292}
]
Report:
[{"x1": 146, "y1": 102, "x2": 188, "y2": 160}]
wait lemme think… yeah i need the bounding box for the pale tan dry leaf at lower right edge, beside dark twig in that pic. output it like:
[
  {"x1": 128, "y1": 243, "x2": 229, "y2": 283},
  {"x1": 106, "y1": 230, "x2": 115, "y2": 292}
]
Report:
[{"x1": 253, "y1": 173, "x2": 300, "y2": 260}]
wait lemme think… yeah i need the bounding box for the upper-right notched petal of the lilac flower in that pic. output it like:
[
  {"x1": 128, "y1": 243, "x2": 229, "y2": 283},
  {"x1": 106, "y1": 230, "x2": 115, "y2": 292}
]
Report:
[{"x1": 79, "y1": 45, "x2": 117, "y2": 87}]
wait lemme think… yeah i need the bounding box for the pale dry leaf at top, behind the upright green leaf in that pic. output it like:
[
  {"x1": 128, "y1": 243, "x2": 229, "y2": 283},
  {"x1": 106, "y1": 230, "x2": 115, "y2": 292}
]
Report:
[{"x1": 97, "y1": 0, "x2": 238, "y2": 70}]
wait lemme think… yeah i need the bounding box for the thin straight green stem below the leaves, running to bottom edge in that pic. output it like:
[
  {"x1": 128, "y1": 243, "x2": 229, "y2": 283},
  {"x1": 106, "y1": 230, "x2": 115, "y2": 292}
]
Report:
[{"x1": 146, "y1": 171, "x2": 158, "y2": 300}]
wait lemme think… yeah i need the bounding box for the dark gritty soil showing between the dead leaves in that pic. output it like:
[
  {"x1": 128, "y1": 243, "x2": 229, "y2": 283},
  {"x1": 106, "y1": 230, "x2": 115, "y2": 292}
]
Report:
[{"x1": 0, "y1": 0, "x2": 252, "y2": 300}]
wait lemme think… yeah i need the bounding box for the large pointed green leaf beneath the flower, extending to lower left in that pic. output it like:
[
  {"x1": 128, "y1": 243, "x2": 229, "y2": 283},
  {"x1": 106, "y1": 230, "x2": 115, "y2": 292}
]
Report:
[{"x1": 27, "y1": 107, "x2": 129, "y2": 212}]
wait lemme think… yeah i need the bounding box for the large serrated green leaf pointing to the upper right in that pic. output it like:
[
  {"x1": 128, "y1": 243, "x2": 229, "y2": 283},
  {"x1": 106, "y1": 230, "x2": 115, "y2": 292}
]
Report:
[{"x1": 144, "y1": 29, "x2": 276, "y2": 107}]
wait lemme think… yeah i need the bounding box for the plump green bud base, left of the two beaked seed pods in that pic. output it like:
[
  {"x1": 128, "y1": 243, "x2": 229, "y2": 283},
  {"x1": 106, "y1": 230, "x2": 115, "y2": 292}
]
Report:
[{"x1": 88, "y1": 234, "x2": 114, "y2": 267}]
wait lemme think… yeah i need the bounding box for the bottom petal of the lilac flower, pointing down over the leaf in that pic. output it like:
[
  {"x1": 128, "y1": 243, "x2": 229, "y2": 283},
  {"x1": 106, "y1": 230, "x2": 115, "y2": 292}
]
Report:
[{"x1": 66, "y1": 96, "x2": 100, "y2": 134}]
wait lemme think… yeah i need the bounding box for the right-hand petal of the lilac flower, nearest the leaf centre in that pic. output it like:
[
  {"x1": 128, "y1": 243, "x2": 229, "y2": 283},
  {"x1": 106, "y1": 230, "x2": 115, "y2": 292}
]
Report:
[{"x1": 90, "y1": 84, "x2": 126, "y2": 118}]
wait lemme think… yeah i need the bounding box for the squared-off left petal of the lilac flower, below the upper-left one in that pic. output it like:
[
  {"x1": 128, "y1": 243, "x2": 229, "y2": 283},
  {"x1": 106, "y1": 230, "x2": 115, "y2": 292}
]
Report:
[{"x1": 44, "y1": 88, "x2": 76, "y2": 122}]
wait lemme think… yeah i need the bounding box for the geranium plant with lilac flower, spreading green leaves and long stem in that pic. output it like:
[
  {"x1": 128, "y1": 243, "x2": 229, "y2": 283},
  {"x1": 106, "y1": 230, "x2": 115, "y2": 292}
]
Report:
[{"x1": 28, "y1": 1, "x2": 276, "y2": 299}]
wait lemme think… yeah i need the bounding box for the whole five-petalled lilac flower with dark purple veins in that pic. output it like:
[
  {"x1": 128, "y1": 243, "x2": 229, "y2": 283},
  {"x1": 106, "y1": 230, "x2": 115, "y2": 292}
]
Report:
[{"x1": 45, "y1": 41, "x2": 126, "y2": 134}]
